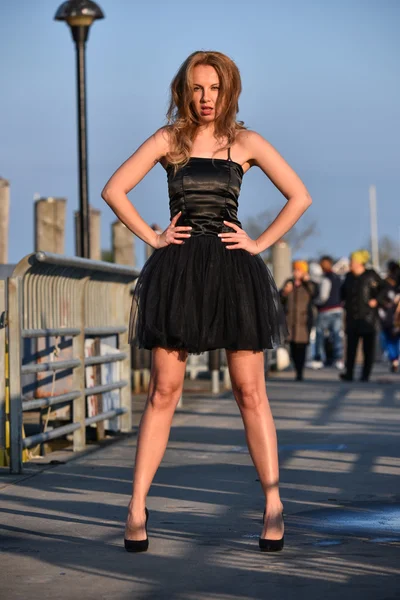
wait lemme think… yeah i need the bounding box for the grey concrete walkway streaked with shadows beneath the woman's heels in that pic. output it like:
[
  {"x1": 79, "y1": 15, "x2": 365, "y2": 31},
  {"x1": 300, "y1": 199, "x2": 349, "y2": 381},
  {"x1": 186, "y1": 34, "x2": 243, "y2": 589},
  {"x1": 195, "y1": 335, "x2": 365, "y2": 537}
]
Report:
[{"x1": 0, "y1": 370, "x2": 400, "y2": 600}]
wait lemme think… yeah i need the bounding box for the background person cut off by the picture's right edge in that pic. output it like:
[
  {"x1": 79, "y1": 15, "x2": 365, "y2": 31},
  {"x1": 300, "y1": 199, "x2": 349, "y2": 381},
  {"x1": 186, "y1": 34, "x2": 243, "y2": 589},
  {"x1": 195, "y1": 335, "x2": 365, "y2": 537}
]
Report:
[{"x1": 378, "y1": 260, "x2": 400, "y2": 373}]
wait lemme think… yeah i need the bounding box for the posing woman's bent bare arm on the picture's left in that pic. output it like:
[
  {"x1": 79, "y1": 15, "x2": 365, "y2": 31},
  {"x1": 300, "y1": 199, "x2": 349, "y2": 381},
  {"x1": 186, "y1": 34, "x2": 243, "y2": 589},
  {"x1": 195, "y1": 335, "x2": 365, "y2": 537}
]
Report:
[{"x1": 101, "y1": 128, "x2": 189, "y2": 248}]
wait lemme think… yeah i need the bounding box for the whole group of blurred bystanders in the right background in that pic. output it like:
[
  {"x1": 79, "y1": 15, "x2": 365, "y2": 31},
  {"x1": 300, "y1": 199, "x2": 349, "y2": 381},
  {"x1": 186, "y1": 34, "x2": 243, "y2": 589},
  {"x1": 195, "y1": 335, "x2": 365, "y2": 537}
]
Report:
[{"x1": 280, "y1": 250, "x2": 400, "y2": 381}]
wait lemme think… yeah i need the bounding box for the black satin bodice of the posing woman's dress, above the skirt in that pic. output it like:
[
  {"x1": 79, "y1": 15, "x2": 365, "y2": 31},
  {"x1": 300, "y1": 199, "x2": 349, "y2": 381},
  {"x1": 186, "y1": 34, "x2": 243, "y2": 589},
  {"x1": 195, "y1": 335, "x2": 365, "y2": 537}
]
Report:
[{"x1": 167, "y1": 157, "x2": 243, "y2": 235}]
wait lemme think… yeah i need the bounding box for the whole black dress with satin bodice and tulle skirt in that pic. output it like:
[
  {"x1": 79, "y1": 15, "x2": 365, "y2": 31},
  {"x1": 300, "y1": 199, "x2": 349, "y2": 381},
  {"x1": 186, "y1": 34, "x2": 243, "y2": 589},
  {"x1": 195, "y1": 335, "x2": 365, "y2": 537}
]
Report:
[{"x1": 129, "y1": 152, "x2": 287, "y2": 354}]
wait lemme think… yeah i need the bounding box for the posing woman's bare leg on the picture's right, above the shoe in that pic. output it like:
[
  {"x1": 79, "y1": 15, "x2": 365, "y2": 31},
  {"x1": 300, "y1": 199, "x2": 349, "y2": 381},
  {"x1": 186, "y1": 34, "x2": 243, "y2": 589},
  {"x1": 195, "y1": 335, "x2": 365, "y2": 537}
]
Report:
[{"x1": 226, "y1": 350, "x2": 283, "y2": 539}]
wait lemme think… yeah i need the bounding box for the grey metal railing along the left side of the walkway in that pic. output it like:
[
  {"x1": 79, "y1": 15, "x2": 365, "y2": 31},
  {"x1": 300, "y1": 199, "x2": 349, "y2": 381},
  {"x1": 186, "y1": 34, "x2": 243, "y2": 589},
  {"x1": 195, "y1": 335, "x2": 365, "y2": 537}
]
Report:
[{"x1": 4, "y1": 252, "x2": 139, "y2": 472}]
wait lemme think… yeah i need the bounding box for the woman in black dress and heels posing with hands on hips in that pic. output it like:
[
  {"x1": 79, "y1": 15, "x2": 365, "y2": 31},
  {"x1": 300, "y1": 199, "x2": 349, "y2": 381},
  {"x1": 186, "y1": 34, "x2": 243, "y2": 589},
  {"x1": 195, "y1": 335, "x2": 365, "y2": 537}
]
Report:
[{"x1": 102, "y1": 52, "x2": 311, "y2": 551}]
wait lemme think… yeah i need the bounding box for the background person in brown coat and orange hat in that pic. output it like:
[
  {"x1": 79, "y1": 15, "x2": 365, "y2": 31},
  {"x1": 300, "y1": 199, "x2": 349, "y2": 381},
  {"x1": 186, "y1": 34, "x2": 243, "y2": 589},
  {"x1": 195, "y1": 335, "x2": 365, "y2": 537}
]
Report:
[{"x1": 281, "y1": 260, "x2": 318, "y2": 381}]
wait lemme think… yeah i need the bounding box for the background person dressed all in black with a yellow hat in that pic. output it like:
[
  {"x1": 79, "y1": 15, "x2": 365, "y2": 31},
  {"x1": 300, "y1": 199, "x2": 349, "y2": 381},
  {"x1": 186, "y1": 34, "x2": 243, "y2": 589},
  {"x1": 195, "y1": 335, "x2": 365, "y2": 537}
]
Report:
[{"x1": 340, "y1": 250, "x2": 387, "y2": 381}]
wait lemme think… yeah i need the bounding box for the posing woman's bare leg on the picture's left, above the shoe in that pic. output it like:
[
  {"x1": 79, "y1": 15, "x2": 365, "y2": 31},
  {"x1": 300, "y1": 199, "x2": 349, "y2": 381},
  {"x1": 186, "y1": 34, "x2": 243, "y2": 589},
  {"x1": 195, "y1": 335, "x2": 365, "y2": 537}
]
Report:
[{"x1": 125, "y1": 348, "x2": 187, "y2": 540}]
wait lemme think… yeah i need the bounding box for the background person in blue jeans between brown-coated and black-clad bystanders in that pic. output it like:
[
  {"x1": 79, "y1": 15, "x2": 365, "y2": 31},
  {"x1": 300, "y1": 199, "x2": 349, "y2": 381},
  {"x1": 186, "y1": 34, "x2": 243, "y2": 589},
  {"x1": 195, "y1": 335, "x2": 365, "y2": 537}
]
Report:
[{"x1": 313, "y1": 256, "x2": 344, "y2": 370}]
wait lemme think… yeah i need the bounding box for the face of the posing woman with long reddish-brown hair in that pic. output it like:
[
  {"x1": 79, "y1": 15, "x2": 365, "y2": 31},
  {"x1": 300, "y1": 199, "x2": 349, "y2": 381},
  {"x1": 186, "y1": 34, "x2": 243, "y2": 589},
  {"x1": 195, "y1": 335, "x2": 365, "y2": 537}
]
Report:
[{"x1": 192, "y1": 65, "x2": 219, "y2": 125}]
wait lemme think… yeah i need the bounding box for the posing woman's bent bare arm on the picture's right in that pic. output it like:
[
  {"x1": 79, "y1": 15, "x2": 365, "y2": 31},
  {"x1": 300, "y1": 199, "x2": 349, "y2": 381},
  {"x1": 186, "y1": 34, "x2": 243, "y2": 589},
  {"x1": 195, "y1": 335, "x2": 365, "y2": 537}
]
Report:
[{"x1": 219, "y1": 131, "x2": 312, "y2": 254}]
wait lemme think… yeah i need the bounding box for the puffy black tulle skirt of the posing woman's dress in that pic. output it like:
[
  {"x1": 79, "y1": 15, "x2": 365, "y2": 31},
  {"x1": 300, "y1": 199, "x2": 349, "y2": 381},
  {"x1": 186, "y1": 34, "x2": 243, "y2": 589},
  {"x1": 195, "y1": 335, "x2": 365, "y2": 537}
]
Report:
[{"x1": 129, "y1": 235, "x2": 287, "y2": 354}]
